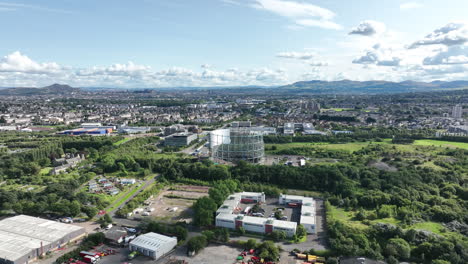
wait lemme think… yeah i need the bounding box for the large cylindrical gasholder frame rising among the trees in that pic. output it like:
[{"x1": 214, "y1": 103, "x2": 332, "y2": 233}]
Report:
[{"x1": 210, "y1": 127, "x2": 265, "y2": 163}]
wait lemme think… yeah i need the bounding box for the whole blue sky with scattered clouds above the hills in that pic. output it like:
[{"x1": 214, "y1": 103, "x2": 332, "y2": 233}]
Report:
[{"x1": 0, "y1": 0, "x2": 468, "y2": 88}]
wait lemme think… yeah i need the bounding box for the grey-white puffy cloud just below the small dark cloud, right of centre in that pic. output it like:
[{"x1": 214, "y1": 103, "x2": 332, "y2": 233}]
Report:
[{"x1": 353, "y1": 44, "x2": 402, "y2": 66}]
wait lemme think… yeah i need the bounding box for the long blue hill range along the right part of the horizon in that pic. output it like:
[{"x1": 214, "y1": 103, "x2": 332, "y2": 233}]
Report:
[{"x1": 276, "y1": 80, "x2": 468, "y2": 94}]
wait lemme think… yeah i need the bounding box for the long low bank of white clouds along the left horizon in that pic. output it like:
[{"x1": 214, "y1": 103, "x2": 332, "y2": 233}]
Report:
[{"x1": 0, "y1": 52, "x2": 289, "y2": 88}]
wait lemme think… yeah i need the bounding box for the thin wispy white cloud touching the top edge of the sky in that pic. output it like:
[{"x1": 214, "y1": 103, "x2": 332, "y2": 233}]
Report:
[{"x1": 222, "y1": 0, "x2": 342, "y2": 30}]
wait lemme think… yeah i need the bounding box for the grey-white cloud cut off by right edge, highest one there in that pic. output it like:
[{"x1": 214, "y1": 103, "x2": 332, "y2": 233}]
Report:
[{"x1": 410, "y1": 22, "x2": 468, "y2": 48}]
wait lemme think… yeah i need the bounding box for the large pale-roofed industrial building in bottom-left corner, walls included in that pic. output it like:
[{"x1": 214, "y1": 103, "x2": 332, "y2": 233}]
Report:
[{"x1": 0, "y1": 215, "x2": 86, "y2": 264}]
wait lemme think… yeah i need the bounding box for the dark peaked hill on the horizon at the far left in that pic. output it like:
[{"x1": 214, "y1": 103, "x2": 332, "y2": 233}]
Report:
[{"x1": 0, "y1": 83, "x2": 81, "y2": 96}]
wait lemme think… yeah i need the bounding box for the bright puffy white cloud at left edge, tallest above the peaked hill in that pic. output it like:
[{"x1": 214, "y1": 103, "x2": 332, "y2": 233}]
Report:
[{"x1": 0, "y1": 51, "x2": 64, "y2": 74}]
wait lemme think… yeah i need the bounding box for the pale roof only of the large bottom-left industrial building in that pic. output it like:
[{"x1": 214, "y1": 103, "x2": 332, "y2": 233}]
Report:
[{"x1": 0, "y1": 215, "x2": 84, "y2": 242}]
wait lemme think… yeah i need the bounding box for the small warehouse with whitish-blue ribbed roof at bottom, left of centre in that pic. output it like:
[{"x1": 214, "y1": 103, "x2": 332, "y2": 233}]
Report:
[{"x1": 129, "y1": 233, "x2": 177, "y2": 260}]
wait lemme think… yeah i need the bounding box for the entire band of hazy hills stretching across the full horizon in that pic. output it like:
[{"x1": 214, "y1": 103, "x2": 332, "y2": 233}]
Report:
[{"x1": 0, "y1": 80, "x2": 468, "y2": 96}]
